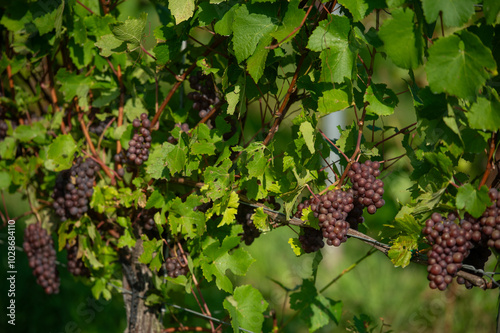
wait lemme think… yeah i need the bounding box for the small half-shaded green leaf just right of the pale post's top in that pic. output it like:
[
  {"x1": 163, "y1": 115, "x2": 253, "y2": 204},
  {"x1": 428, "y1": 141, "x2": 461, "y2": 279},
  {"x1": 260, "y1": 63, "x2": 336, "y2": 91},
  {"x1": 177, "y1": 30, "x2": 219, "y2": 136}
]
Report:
[{"x1": 364, "y1": 84, "x2": 399, "y2": 116}]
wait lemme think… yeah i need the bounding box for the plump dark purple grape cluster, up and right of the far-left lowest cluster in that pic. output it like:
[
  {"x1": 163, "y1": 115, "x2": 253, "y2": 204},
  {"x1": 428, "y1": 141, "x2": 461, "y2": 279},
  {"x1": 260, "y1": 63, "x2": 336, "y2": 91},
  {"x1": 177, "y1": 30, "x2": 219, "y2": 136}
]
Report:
[{"x1": 52, "y1": 157, "x2": 101, "y2": 221}]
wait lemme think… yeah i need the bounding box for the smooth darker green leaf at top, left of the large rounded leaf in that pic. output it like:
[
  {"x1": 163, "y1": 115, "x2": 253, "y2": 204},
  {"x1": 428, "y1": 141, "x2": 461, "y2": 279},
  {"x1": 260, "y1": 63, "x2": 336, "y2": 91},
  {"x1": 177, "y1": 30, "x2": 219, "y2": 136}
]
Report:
[{"x1": 379, "y1": 8, "x2": 423, "y2": 69}]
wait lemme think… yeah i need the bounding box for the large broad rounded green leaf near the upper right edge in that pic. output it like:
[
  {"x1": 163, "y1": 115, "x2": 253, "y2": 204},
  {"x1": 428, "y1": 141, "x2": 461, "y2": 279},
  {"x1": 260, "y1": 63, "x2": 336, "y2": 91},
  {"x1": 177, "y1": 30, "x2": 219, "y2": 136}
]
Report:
[{"x1": 425, "y1": 31, "x2": 496, "y2": 100}]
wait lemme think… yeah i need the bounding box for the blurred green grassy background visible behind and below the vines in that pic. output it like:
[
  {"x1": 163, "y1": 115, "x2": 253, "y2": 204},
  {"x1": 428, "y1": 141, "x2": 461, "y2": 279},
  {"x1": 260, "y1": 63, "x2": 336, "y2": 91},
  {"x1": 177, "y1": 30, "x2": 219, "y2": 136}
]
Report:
[{"x1": 0, "y1": 1, "x2": 498, "y2": 333}]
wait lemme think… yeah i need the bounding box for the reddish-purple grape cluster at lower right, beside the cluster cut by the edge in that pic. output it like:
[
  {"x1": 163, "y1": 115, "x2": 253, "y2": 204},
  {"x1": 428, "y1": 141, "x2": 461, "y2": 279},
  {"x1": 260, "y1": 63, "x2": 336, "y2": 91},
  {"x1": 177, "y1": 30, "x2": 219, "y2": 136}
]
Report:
[{"x1": 423, "y1": 213, "x2": 472, "y2": 290}]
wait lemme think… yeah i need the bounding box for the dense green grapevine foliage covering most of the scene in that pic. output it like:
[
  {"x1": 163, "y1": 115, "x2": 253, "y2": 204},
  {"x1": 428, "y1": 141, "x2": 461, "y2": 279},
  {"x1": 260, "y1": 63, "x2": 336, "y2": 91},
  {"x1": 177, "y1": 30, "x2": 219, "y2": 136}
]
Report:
[{"x1": 0, "y1": 0, "x2": 500, "y2": 332}]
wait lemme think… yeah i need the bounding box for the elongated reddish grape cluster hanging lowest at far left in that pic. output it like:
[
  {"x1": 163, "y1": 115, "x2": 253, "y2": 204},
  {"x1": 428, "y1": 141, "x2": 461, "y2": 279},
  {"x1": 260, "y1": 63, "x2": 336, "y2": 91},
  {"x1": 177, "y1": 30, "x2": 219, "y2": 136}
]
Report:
[{"x1": 23, "y1": 224, "x2": 60, "y2": 294}]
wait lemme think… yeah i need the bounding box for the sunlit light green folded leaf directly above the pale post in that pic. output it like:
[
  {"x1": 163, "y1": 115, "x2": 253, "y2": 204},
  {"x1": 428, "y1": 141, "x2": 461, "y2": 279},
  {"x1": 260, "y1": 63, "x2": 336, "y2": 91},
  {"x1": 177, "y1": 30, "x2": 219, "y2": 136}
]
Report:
[{"x1": 307, "y1": 16, "x2": 356, "y2": 83}]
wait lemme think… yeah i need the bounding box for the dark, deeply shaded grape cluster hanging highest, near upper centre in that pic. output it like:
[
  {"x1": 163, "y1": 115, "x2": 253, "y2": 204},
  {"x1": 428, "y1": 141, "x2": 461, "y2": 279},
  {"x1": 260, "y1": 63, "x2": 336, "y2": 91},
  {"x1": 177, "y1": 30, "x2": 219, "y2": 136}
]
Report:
[{"x1": 187, "y1": 72, "x2": 219, "y2": 118}]
